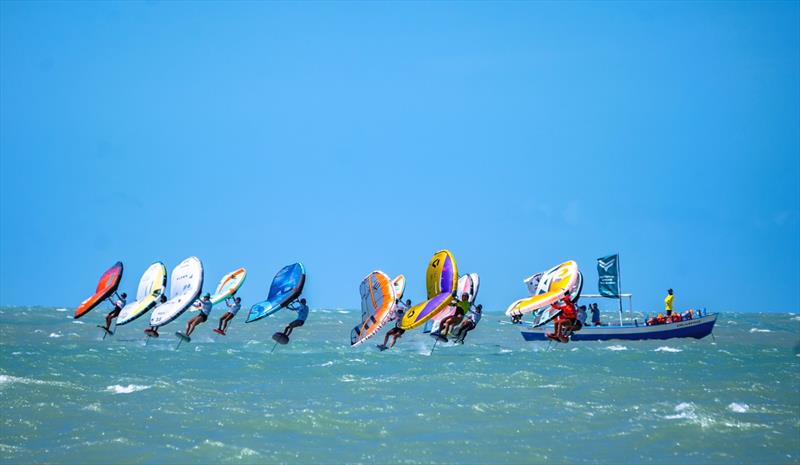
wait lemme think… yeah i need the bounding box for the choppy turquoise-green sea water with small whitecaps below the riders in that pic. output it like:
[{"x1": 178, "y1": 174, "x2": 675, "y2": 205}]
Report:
[{"x1": 0, "y1": 307, "x2": 800, "y2": 464}]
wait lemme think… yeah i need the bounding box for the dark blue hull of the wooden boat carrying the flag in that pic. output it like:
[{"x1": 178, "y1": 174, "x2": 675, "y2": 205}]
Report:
[{"x1": 522, "y1": 313, "x2": 718, "y2": 341}]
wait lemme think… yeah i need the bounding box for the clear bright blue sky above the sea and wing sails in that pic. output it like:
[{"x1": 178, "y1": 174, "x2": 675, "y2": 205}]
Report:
[{"x1": 0, "y1": 1, "x2": 800, "y2": 311}]
